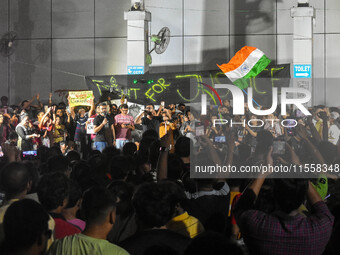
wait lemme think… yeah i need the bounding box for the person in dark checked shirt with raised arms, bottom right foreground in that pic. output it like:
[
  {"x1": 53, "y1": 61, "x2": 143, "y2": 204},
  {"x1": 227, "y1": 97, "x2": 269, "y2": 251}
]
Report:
[{"x1": 235, "y1": 148, "x2": 334, "y2": 254}]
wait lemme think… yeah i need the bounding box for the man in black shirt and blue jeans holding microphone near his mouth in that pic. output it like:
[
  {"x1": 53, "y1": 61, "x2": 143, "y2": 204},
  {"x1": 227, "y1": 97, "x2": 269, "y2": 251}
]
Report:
[{"x1": 93, "y1": 103, "x2": 116, "y2": 152}]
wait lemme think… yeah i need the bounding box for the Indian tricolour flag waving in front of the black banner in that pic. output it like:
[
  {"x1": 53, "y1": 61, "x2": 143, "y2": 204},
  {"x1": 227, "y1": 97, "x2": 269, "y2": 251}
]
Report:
[{"x1": 217, "y1": 46, "x2": 271, "y2": 89}]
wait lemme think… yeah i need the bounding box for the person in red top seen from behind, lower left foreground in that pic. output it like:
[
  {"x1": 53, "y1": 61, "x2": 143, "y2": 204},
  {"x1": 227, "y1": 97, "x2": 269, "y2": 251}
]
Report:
[{"x1": 37, "y1": 172, "x2": 81, "y2": 239}]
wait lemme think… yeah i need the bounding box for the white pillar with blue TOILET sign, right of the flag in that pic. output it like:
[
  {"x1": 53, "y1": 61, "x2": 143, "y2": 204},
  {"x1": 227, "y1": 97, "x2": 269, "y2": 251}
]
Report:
[{"x1": 290, "y1": 0, "x2": 315, "y2": 106}]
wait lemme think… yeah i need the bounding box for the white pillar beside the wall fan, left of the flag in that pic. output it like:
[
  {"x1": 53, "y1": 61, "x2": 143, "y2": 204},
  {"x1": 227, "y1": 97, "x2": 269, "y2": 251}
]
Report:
[{"x1": 124, "y1": 10, "x2": 151, "y2": 74}]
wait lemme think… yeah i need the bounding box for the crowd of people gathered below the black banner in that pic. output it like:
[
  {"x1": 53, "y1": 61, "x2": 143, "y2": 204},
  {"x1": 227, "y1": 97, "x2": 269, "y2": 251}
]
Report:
[{"x1": 0, "y1": 94, "x2": 340, "y2": 255}]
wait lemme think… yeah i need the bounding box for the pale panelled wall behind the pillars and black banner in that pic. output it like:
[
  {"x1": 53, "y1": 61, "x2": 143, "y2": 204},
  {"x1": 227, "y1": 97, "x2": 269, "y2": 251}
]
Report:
[{"x1": 0, "y1": 0, "x2": 340, "y2": 106}]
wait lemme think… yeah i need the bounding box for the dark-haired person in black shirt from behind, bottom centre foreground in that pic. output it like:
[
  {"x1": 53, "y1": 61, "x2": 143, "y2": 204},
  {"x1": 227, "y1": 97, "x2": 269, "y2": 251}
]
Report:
[{"x1": 119, "y1": 183, "x2": 190, "y2": 255}]
